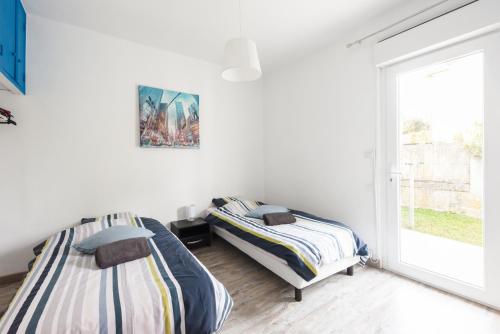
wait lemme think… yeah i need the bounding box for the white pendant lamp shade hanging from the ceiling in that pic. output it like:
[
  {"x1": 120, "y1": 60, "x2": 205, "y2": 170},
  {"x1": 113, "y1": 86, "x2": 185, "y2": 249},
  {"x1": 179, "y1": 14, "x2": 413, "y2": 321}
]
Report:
[{"x1": 222, "y1": 38, "x2": 262, "y2": 82}]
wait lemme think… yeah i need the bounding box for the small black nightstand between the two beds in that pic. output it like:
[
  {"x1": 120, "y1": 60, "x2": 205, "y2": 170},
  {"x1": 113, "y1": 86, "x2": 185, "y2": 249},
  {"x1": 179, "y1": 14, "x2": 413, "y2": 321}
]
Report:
[{"x1": 170, "y1": 218, "x2": 212, "y2": 249}]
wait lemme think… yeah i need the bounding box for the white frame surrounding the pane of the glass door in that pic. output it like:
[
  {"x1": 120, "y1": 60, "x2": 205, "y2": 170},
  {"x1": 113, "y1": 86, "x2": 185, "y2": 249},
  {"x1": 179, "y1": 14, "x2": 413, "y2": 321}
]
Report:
[{"x1": 376, "y1": 33, "x2": 500, "y2": 309}]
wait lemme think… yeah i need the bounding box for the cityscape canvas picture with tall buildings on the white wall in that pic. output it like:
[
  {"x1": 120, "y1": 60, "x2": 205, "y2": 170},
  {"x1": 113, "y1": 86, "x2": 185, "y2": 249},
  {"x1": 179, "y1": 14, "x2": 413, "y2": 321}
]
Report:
[{"x1": 139, "y1": 86, "x2": 200, "y2": 148}]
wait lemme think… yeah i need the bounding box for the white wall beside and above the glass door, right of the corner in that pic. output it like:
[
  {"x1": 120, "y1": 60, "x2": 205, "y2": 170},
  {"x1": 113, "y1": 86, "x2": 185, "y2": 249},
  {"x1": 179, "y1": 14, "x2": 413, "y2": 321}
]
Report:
[{"x1": 264, "y1": 0, "x2": 498, "y2": 255}]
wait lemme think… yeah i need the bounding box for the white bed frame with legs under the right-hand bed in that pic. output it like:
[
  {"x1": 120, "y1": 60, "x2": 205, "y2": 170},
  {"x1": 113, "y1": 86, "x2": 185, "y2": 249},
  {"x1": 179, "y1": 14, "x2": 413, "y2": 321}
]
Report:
[{"x1": 213, "y1": 226, "x2": 360, "y2": 301}]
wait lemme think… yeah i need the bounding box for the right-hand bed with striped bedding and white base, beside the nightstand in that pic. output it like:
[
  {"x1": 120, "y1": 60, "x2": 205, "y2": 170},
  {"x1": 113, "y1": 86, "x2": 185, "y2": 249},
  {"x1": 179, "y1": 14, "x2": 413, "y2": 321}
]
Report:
[{"x1": 206, "y1": 197, "x2": 369, "y2": 301}]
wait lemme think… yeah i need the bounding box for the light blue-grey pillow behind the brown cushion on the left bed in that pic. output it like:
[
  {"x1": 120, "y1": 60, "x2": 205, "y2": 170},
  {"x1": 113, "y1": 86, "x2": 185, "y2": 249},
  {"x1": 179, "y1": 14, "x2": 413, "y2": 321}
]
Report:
[{"x1": 73, "y1": 225, "x2": 155, "y2": 254}]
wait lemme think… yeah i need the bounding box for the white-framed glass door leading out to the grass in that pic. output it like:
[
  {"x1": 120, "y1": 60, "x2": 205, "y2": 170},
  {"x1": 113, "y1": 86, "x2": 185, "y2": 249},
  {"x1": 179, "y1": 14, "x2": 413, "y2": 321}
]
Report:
[{"x1": 384, "y1": 33, "x2": 500, "y2": 303}]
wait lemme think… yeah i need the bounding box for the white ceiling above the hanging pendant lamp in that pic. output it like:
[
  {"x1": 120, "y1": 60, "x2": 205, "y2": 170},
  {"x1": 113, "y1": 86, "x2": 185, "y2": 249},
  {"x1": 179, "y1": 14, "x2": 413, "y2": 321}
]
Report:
[{"x1": 24, "y1": 0, "x2": 409, "y2": 71}]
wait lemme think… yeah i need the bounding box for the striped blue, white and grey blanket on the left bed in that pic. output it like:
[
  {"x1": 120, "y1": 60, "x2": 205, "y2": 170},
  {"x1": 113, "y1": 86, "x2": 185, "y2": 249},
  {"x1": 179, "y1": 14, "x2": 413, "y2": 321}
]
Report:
[{"x1": 0, "y1": 213, "x2": 233, "y2": 334}]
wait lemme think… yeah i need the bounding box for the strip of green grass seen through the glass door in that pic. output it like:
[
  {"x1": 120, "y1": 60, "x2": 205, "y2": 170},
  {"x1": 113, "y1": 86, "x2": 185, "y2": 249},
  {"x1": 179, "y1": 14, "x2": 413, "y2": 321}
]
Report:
[{"x1": 401, "y1": 207, "x2": 483, "y2": 246}]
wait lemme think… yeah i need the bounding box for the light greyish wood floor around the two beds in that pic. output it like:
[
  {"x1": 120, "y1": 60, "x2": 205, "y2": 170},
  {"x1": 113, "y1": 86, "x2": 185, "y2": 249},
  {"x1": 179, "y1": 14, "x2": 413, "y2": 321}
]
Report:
[{"x1": 0, "y1": 239, "x2": 500, "y2": 334}]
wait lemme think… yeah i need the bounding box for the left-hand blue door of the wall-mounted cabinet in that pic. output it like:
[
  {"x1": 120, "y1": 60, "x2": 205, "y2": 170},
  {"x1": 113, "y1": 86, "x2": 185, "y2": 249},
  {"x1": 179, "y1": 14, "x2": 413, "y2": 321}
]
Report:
[{"x1": 0, "y1": 0, "x2": 16, "y2": 80}]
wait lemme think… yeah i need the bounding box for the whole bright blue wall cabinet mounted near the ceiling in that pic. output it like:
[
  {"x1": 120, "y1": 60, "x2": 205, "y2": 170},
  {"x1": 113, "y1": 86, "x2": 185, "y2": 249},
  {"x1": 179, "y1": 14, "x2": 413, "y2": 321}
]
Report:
[{"x1": 0, "y1": 0, "x2": 26, "y2": 94}]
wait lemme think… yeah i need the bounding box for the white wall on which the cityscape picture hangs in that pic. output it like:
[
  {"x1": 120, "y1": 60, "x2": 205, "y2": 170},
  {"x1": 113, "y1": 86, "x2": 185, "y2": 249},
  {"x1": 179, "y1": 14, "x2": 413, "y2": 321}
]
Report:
[{"x1": 0, "y1": 16, "x2": 263, "y2": 276}]
